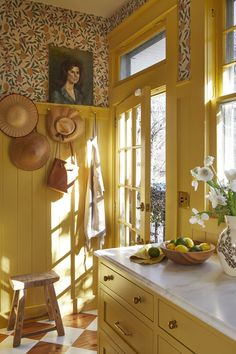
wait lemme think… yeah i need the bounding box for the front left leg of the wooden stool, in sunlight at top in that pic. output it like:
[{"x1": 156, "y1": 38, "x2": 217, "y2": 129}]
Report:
[{"x1": 13, "y1": 289, "x2": 26, "y2": 347}]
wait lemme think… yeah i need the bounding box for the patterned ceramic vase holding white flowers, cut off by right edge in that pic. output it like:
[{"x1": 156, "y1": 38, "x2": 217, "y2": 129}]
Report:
[{"x1": 217, "y1": 216, "x2": 236, "y2": 276}]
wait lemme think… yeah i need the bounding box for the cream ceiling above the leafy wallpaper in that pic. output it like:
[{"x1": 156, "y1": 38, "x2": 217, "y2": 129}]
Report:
[{"x1": 31, "y1": 0, "x2": 127, "y2": 17}]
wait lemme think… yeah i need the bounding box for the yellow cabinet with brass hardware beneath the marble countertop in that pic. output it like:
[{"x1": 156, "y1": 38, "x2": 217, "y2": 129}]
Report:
[{"x1": 98, "y1": 259, "x2": 236, "y2": 354}]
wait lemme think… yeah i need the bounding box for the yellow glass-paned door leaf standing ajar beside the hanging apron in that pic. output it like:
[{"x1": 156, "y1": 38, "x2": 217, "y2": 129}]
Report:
[{"x1": 116, "y1": 87, "x2": 151, "y2": 246}]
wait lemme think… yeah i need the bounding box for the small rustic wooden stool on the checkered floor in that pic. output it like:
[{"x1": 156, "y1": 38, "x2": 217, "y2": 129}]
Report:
[{"x1": 7, "y1": 270, "x2": 65, "y2": 347}]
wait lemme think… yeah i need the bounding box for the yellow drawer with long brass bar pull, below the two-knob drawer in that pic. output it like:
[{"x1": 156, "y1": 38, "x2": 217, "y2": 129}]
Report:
[{"x1": 100, "y1": 291, "x2": 153, "y2": 354}]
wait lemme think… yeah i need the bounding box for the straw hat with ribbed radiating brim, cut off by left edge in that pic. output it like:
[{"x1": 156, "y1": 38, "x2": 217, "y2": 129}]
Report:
[{"x1": 0, "y1": 93, "x2": 38, "y2": 138}]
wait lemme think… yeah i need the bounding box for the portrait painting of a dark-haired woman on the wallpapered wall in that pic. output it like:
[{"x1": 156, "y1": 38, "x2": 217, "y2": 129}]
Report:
[{"x1": 49, "y1": 46, "x2": 93, "y2": 106}]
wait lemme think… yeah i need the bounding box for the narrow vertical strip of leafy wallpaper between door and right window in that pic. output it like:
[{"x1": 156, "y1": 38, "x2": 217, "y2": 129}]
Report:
[{"x1": 178, "y1": 0, "x2": 191, "y2": 81}]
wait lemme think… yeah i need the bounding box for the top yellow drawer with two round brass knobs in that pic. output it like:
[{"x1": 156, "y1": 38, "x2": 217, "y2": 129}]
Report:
[{"x1": 99, "y1": 264, "x2": 154, "y2": 320}]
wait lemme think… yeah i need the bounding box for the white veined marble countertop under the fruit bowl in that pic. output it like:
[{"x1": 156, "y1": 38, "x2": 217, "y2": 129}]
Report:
[{"x1": 95, "y1": 246, "x2": 236, "y2": 340}]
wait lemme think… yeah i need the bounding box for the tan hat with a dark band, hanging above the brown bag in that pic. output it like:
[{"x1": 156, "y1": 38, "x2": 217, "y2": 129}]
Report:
[{"x1": 47, "y1": 107, "x2": 85, "y2": 143}]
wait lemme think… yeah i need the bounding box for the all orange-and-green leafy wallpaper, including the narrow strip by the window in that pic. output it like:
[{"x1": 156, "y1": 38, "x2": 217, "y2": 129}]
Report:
[{"x1": 0, "y1": 0, "x2": 190, "y2": 107}]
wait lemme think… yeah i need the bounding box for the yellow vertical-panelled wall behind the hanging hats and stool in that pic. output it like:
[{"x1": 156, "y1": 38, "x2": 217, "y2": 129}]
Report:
[{"x1": 0, "y1": 103, "x2": 111, "y2": 325}]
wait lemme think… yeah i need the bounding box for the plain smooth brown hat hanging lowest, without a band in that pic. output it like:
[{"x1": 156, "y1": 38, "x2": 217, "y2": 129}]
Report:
[{"x1": 9, "y1": 132, "x2": 50, "y2": 171}]
